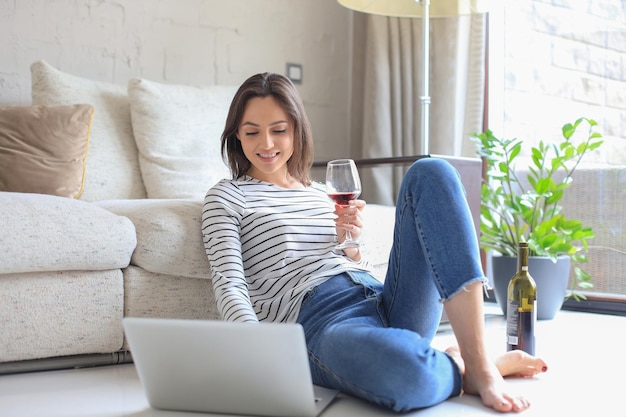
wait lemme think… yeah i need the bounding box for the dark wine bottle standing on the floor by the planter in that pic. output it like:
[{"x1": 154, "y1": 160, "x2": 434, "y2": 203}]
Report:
[{"x1": 506, "y1": 242, "x2": 537, "y2": 355}]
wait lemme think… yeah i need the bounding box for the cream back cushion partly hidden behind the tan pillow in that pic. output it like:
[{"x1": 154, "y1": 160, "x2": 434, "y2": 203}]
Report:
[{"x1": 31, "y1": 61, "x2": 146, "y2": 201}]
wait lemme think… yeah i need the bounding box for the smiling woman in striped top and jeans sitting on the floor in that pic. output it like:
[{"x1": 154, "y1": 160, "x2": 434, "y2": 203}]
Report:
[{"x1": 202, "y1": 73, "x2": 547, "y2": 412}]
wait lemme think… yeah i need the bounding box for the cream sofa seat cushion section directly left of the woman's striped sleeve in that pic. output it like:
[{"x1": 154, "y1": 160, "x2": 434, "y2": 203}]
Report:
[{"x1": 97, "y1": 199, "x2": 211, "y2": 279}]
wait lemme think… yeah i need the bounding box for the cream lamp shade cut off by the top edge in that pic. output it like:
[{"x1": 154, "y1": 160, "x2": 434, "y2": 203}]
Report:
[{"x1": 338, "y1": 0, "x2": 489, "y2": 17}]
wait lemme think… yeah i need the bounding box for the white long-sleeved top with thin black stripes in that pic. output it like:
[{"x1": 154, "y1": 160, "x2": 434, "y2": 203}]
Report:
[{"x1": 202, "y1": 177, "x2": 369, "y2": 322}]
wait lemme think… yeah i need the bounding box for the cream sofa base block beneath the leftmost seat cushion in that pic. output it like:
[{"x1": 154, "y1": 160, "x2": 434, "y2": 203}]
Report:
[{"x1": 0, "y1": 269, "x2": 124, "y2": 360}]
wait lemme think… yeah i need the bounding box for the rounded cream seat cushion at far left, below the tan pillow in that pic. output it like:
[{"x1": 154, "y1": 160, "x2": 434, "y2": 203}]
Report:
[{"x1": 0, "y1": 192, "x2": 137, "y2": 274}]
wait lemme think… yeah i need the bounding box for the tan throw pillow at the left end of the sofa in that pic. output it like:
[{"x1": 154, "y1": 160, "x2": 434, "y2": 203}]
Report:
[{"x1": 0, "y1": 104, "x2": 94, "y2": 198}]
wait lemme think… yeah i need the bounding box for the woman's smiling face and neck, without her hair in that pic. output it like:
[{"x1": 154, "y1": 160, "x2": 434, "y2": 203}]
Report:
[{"x1": 237, "y1": 96, "x2": 294, "y2": 188}]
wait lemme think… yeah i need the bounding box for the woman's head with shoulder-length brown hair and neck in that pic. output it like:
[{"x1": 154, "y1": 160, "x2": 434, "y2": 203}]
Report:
[{"x1": 222, "y1": 73, "x2": 313, "y2": 188}]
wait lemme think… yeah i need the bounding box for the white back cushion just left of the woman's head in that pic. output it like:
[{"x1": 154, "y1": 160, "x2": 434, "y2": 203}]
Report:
[{"x1": 128, "y1": 79, "x2": 237, "y2": 198}]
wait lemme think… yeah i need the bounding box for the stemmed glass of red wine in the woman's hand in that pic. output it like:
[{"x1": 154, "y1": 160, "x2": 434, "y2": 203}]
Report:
[{"x1": 326, "y1": 159, "x2": 361, "y2": 249}]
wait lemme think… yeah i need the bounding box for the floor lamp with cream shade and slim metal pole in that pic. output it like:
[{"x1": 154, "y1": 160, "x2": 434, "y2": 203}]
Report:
[{"x1": 338, "y1": 0, "x2": 489, "y2": 155}]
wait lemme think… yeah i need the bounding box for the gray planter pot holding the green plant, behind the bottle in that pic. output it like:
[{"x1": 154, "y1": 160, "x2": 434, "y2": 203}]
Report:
[{"x1": 491, "y1": 256, "x2": 570, "y2": 320}]
